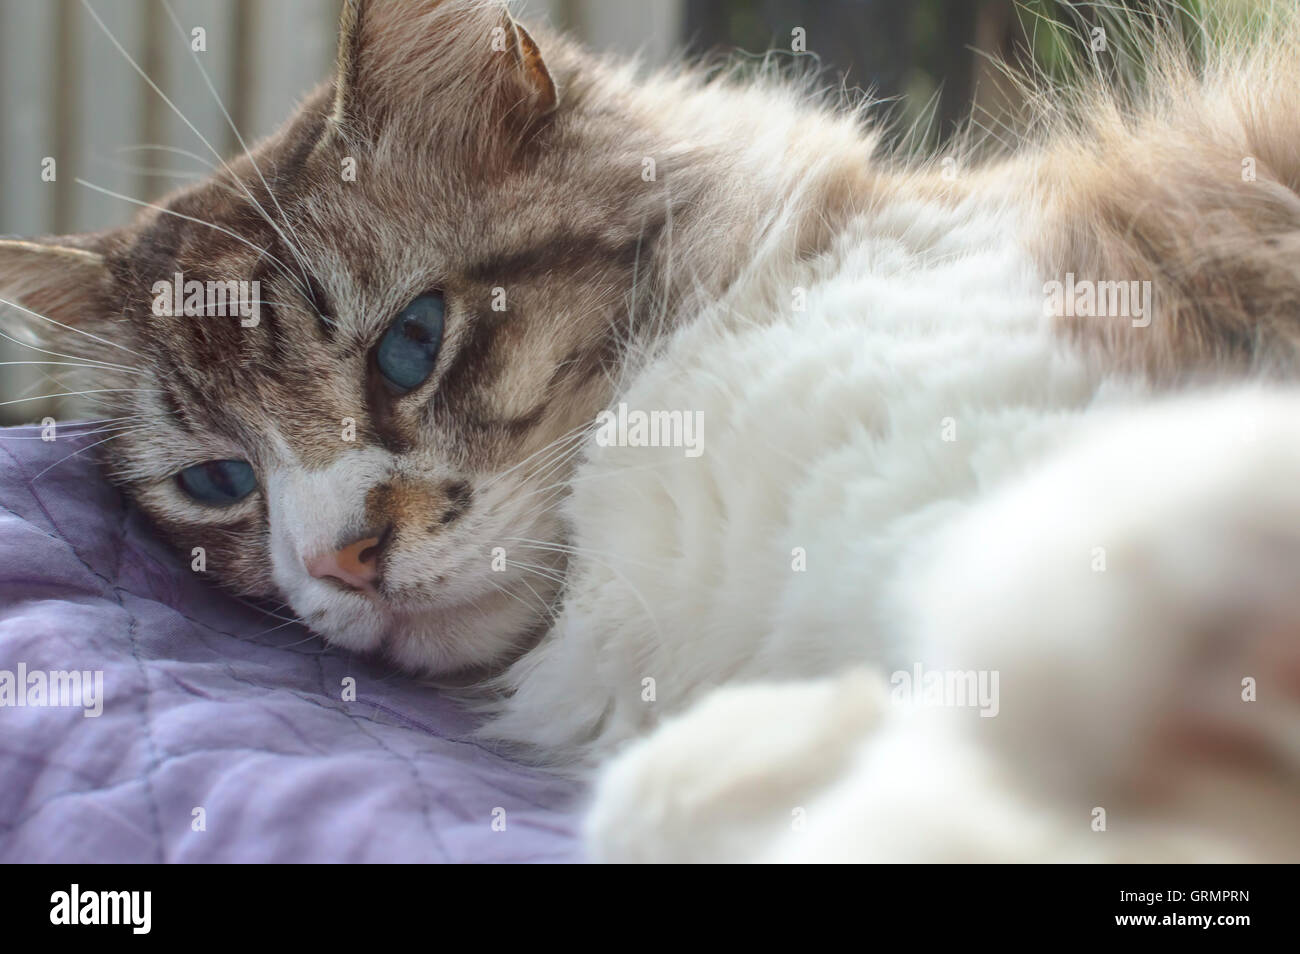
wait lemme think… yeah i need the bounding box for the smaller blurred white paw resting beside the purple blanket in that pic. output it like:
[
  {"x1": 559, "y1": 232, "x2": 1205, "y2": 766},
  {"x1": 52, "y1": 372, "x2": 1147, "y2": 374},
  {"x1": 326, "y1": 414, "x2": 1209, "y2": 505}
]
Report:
[{"x1": 586, "y1": 671, "x2": 887, "y2": 862}]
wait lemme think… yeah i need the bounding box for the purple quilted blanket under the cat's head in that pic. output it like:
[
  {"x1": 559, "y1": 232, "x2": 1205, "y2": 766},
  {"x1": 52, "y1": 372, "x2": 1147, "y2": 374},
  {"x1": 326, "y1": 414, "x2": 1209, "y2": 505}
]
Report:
[{"x1": 0, "y1": 429, "x2": 581, "y2": 862}]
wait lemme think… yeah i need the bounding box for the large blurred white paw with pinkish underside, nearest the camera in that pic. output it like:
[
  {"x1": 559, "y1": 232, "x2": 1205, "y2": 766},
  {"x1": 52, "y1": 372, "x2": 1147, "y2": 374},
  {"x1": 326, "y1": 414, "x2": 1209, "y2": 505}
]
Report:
[{"x1": 910, "y1": 393, "x2": 1300, "y2": 860}]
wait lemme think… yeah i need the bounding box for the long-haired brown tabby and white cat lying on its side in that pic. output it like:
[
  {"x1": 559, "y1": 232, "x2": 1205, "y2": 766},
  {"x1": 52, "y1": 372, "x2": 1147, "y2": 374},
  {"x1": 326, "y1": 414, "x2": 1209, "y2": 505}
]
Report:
[{"x1": 0, "y1": 0, "x2": 1300, "y2": 862}]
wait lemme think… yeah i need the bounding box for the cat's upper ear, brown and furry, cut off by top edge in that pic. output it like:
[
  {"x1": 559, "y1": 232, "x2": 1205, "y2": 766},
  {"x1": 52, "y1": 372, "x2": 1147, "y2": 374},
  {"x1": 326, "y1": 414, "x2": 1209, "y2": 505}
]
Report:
[{"x1": 333, "y1": 0, "x2": 559, "y2": 151}]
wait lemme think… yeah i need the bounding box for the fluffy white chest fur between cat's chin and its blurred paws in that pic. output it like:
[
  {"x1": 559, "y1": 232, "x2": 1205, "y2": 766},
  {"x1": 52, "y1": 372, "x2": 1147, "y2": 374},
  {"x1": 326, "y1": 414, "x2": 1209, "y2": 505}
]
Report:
[{"x1": 489, "y1": 192, "x2": 1123, "y2": 758}]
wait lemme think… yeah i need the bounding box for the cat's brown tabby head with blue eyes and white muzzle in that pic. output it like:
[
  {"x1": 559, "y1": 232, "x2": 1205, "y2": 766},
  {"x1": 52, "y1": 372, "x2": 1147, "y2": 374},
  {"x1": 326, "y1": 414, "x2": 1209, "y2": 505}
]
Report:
[{"x1": 0, "y1": 1, "x2": 663, "y2": 672}]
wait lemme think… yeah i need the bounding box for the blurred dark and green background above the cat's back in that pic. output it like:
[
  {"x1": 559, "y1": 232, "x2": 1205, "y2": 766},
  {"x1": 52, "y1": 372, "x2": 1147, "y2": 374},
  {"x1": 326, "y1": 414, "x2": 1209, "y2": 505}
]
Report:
[{"x1": 685, "y1": 0, "x2": 1216, "y2": 147}]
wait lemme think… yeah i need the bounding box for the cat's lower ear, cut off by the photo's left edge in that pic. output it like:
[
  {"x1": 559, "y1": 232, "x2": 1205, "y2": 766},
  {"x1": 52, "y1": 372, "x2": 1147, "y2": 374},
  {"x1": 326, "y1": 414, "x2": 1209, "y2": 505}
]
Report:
[{"x1": 0, "y1": 237, "x2": 109, "y2": 343}]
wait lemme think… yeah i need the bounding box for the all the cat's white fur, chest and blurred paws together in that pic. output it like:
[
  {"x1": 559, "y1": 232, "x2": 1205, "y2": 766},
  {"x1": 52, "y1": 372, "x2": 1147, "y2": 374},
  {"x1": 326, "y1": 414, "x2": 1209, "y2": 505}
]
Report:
[{"x1": 486, "y1": 183, "x2": 1300, "y2": 860}]
